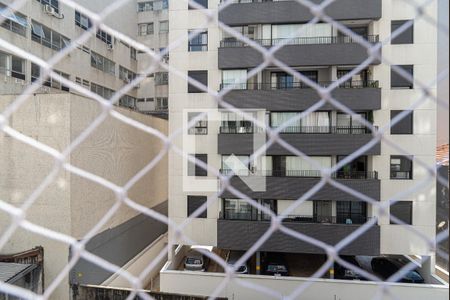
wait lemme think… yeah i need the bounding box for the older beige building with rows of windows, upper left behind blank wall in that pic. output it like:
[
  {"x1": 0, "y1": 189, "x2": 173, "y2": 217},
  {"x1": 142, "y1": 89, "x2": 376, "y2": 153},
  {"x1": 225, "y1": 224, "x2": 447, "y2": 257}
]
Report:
[{"x1": 0, "y1": 0, "x2": 168, "y2": 115}]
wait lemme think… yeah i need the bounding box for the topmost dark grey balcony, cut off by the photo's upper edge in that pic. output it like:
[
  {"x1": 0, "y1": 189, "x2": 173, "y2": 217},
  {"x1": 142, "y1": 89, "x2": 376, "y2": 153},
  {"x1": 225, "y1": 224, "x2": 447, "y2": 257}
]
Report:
[{"x1": 219, "y1": 0, "x2": 381, "y2": 26}]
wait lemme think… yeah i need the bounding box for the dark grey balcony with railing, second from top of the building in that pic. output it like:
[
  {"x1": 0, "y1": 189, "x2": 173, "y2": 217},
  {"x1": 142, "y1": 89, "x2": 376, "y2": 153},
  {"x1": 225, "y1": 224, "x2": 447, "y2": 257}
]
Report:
[{"x1": 219, "y1": 35, "x2": 380, "y2": 69}]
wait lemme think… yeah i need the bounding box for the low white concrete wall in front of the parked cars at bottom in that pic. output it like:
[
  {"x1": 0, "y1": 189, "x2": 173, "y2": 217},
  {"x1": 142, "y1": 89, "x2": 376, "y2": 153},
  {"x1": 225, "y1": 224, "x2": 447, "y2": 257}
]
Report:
[{"x1": 160, "y1": 270, "x2": 448, "y2": 300}]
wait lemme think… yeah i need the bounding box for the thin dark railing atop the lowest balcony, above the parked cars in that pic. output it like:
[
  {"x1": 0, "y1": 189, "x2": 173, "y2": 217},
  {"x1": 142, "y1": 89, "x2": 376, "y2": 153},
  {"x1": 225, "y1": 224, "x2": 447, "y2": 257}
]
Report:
[{"x1": 219, "y1": 209, "x2": 371, "y2": 225}]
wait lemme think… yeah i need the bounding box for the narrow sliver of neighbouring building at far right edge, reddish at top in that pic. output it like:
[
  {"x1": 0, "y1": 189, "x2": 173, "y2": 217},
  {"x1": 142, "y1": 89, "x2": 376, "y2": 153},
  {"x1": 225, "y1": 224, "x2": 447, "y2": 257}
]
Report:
[{"x1": 436, "y1": 144, "x2": 450, "y2": 271}]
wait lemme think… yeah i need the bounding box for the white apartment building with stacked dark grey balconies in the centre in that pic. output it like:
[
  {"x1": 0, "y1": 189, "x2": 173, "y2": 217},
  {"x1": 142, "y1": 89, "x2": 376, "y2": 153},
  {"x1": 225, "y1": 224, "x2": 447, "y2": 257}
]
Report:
[{"x1": 169, "y1": 0, "x2": 437, "y2": 290}]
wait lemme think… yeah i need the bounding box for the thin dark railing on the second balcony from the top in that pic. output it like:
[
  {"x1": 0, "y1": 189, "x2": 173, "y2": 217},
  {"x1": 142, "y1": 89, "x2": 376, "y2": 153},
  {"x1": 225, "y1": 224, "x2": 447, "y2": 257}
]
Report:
[{"x1": 220, "y1": 35, "x2": 379, "y2": 48}]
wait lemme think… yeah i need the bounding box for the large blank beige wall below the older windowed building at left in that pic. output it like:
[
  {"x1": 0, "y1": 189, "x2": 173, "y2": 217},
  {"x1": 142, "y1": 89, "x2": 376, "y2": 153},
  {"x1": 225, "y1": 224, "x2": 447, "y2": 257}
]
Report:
[{"x1": 0, "y1": 93, "x2": 167, "y2": 299}]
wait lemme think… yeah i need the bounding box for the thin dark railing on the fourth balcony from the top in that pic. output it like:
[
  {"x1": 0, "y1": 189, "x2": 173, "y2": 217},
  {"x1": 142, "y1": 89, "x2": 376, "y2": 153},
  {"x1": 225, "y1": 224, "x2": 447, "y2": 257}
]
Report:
[{"x1": 219, "y1": 126, "x2": 377, "y2": 134}]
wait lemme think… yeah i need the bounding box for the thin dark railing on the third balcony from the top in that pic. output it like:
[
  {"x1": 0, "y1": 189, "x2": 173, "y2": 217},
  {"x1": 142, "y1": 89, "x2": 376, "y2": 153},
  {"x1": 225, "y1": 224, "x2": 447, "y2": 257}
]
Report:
[{"x1": 220, "y1": 80, "x2": 379, "y2": 91}]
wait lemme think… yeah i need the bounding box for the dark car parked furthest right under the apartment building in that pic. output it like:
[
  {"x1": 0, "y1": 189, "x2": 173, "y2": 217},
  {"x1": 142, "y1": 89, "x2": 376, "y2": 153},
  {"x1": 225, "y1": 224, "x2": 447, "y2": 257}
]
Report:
[{"x1": 371, "y1": 257, "x2": 425, "y2": 283}]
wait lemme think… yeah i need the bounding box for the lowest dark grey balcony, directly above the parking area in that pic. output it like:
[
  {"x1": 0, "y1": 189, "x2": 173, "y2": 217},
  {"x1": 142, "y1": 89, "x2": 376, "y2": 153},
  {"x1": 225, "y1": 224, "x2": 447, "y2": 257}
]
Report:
[{"x1": 217, "y1": 216, "x2": 380, "y2": 256}]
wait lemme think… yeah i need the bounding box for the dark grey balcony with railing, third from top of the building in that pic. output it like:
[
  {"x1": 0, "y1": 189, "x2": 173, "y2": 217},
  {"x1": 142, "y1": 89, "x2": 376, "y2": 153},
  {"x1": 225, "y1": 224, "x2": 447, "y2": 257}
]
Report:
[{"x1": 221, "y1": 80, "x2": 381, "y2": 111}]
